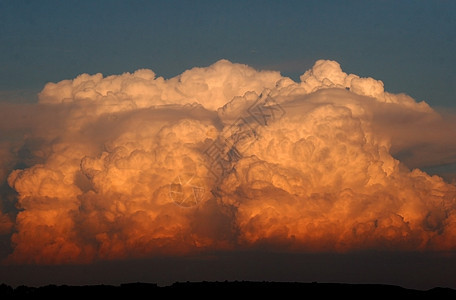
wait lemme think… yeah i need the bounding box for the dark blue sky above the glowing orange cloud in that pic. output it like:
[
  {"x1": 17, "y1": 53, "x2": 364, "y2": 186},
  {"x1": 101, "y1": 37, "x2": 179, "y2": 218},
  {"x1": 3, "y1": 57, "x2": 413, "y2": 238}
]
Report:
[{"x1": 0, "y1": 0, "x2": 456, "y2": 107}]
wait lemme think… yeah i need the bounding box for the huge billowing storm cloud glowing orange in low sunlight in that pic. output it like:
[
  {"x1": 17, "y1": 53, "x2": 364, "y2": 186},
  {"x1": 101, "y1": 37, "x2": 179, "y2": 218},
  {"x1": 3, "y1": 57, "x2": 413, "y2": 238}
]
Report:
[{"x1": 0, "y1": 60, "x2": 456, "y2": 264}]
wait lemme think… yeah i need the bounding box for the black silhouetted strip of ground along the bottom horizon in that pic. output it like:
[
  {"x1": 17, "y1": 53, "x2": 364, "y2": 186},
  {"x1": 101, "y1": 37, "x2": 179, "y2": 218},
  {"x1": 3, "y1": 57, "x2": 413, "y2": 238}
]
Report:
[{"x1": 0, "y1": 281, "x2": 456, "y2": 299}]
